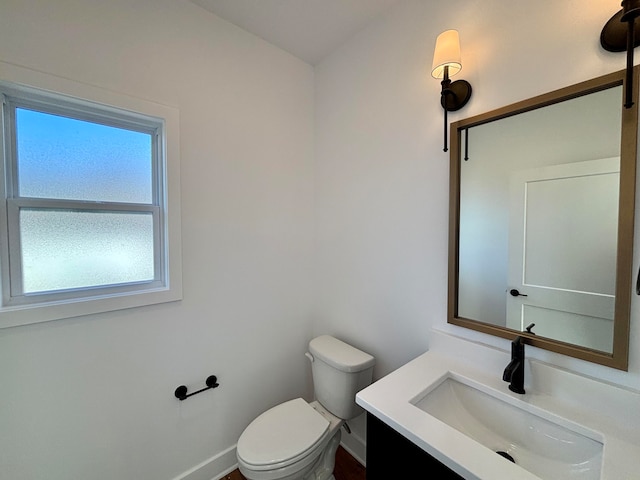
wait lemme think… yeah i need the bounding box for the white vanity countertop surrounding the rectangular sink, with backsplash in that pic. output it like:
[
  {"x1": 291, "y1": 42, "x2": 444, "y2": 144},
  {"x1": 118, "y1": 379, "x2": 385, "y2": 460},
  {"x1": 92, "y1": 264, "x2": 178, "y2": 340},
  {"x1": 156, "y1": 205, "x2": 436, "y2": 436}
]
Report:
[{"x1": 356, "y1": 344, "x2": 640, "y2": 480}]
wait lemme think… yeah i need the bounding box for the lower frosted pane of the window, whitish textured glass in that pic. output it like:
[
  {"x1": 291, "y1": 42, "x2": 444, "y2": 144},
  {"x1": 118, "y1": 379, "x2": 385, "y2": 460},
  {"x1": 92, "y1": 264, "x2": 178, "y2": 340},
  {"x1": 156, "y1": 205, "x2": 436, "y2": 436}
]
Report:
[{"x1": 20, "y1": 209, "x2": 154, "y2": 293}]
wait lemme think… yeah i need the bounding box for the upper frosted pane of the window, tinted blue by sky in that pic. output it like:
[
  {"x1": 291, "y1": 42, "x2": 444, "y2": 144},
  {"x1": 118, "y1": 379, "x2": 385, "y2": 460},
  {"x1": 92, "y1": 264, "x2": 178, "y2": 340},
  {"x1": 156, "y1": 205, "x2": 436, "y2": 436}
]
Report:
[{"x1": 16, "y1": 108, "x2": 153, "y2": 204}]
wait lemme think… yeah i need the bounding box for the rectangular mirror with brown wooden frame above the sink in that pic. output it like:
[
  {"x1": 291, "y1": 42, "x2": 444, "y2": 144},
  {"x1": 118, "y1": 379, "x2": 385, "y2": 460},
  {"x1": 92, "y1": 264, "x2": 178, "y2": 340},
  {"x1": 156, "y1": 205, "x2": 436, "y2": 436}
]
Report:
[{"x1": 448, "y1": 67, "x2": 638, "y2": 370}]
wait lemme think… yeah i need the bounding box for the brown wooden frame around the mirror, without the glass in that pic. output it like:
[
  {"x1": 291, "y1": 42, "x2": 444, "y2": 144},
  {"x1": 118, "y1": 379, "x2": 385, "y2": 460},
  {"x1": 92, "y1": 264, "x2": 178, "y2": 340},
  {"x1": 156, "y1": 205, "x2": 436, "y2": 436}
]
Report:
[{"x1": 447, "y1": 67, "x2": 640, "y2": 370}]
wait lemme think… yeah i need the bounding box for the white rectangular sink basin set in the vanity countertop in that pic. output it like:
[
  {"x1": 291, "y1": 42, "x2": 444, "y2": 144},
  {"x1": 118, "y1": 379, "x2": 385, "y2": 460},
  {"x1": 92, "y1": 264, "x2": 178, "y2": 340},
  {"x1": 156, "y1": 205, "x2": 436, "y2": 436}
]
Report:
[{"x1": 411, "y1": 373, "x2": 603, "y2": 480}]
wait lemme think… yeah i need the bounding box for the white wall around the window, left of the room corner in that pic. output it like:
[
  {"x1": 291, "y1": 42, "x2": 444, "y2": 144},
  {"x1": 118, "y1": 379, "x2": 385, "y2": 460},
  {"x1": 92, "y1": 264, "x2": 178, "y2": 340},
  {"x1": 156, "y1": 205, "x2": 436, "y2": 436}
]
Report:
[{"x1": 0, "y1": 0, "x2": 314, "y2": 480}]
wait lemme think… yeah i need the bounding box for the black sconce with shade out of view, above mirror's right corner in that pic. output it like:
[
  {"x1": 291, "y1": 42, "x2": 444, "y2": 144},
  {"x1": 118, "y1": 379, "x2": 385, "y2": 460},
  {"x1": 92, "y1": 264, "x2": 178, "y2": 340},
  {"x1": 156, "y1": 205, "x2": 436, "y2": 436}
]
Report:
[{"x1": 600, "y1": 0, "x2": 640, "y2": 108}]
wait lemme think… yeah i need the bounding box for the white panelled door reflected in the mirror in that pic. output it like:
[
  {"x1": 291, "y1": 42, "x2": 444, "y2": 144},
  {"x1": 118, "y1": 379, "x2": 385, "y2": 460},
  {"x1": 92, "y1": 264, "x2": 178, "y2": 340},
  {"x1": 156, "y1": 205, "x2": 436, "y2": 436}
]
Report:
[{"x1": 506, "y1": 157, "x2": 620, "y2": 352}]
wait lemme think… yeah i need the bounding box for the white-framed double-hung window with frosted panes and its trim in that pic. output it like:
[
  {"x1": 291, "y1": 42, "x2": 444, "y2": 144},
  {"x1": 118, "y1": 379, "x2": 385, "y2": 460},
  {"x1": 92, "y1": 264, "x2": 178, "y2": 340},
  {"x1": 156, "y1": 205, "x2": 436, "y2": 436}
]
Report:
[{"x1": 0, "y1": 80, "x2": 180, "y2": 327}]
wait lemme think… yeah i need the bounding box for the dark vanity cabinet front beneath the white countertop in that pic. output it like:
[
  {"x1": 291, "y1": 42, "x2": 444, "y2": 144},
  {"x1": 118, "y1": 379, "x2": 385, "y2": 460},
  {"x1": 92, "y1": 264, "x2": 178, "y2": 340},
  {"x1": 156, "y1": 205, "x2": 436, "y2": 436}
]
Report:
[{"x1": 367, "y1": 412, "x2": 464, "y2": 480}]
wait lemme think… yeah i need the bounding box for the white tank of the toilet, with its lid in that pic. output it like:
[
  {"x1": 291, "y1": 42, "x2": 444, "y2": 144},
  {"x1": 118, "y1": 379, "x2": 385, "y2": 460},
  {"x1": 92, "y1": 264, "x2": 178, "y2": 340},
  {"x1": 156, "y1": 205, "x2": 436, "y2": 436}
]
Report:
[{"x1": 309, "y1": 335, "x2": 375, "y2": 420}]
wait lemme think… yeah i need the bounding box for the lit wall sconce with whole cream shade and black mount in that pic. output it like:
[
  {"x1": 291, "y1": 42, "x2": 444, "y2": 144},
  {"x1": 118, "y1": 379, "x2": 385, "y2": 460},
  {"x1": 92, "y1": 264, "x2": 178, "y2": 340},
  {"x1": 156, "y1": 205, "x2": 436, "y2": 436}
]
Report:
[{"x1": 431, "y1": 30, "x2": 472, "y2": 152}]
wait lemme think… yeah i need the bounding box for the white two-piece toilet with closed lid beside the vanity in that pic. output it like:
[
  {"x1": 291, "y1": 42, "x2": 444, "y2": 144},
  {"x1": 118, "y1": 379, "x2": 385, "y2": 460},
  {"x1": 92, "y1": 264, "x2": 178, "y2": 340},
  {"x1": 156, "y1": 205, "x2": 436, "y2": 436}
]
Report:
[{"x1": 237, "y1": 335, "x2": 375, "y2": 480}]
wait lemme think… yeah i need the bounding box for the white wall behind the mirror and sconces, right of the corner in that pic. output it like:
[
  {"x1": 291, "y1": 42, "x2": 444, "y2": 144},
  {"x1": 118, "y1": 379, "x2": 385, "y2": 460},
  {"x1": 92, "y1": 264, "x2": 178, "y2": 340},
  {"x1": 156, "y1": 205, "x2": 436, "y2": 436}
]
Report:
[{"x1": 315, "y1": 0, "x2": 640, "y2": 388}]
